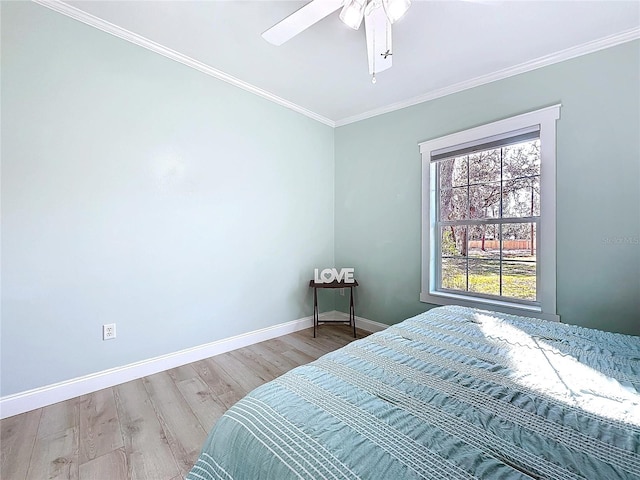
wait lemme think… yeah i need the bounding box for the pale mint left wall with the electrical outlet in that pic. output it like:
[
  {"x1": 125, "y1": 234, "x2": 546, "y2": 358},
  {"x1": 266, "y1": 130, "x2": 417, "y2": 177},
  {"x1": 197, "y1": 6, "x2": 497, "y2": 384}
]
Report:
[{"x1": 1, "y1": 2, "x2": 334, "y2": 395}]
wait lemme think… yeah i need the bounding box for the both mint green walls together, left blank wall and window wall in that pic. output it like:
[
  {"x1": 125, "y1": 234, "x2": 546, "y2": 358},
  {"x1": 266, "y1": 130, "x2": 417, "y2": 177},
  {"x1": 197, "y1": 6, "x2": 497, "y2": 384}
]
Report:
[{"x1": 0, "y1": 2, "x2": 640, "y2": 396}]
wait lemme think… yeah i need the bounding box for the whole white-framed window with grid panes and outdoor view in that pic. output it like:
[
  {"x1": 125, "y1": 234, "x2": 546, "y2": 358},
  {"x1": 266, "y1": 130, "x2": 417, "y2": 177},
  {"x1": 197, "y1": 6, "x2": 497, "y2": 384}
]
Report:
[{"x1": 420, "y1": 105, "x2": 560, "y2": 320}]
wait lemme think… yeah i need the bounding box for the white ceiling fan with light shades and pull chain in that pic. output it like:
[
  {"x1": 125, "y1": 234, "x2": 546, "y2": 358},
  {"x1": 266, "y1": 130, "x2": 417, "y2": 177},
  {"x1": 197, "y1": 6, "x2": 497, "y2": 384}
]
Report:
[{"x1": 262, "y1": 0, "x2": 411, "y2": 83}]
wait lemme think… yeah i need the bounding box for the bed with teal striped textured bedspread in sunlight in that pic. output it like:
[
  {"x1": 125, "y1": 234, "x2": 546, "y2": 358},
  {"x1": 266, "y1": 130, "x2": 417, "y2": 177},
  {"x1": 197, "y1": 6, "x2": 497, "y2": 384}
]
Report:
[{"x1": 187, "y1": 306, "x2": 640, "y2": 480}]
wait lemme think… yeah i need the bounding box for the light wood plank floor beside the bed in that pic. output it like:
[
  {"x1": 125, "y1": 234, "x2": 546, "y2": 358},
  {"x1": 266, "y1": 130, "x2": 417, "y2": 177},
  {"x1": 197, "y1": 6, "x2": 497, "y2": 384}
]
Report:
[{"x1": 0, "y1": 325, "x2": 367, "y2": 480}]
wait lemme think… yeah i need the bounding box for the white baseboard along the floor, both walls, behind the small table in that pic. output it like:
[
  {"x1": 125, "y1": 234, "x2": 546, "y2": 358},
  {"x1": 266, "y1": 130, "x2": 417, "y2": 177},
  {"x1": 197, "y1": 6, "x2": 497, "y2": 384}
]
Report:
[{"x1": 0, "y1": 311, "x2": 387, "y2": 418}]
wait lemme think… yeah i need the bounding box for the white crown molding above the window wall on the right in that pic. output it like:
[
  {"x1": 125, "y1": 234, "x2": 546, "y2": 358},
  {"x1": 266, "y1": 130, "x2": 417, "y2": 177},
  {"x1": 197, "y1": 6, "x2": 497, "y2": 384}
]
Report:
[{"x1": 335, "y1": 27, "x2": 640, "y2": 127}]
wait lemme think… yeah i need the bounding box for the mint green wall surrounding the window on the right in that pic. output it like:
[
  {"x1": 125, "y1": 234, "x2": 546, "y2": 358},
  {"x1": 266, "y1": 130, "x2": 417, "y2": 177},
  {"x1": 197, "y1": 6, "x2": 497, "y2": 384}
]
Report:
[{"x1": 335, "y1": 41, "x2": 640, "y2": 335}]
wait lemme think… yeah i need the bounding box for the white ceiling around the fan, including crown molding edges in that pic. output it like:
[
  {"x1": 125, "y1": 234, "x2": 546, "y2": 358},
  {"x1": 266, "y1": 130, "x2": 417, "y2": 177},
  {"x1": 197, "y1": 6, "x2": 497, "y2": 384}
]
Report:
[{"x1": 46, "y1": 0, "x2": 640, "y2": 125}]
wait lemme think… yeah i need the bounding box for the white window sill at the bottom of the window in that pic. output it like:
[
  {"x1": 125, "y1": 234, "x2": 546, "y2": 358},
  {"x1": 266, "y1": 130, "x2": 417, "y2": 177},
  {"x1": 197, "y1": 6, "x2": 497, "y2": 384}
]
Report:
[{"x1": 420, "y1": 292, "x2": 560, "y2": 322}]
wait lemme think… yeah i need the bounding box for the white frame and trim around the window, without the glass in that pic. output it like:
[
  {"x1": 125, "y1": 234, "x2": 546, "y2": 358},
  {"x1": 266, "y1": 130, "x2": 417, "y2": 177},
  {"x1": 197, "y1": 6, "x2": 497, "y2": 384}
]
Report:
[{"x1": 419, "y1": 105, "x2": 561, "y2": 321}]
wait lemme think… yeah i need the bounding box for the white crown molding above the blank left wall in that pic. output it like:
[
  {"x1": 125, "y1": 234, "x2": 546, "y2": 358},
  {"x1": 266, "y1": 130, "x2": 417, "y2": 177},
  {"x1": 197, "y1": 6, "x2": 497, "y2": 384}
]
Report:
[{"x1": 32, "y1": 0, "x2": 336, "y2": 127}]
